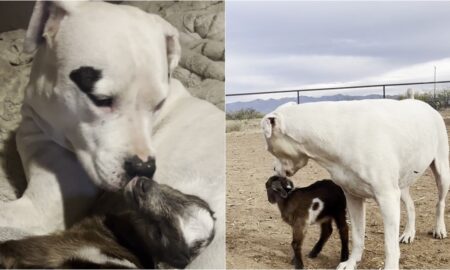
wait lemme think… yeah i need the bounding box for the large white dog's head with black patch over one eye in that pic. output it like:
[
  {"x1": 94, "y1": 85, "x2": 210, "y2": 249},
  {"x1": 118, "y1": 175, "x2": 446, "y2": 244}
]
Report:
[{"x1": 25, "y1": 1, "x2": 181, "y2": 189}]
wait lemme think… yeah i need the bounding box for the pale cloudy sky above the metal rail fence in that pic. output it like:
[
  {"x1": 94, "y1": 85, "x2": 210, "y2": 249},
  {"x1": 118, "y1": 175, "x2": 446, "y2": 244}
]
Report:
[{"x1": 226, "y1": 1, "x2": 450, "y2": 102}]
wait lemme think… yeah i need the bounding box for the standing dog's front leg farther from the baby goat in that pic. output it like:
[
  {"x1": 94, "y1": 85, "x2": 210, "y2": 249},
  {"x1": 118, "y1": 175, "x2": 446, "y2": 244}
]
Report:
[{"x1": 375, "y1": 189, "x2": 401, "y2": 269}]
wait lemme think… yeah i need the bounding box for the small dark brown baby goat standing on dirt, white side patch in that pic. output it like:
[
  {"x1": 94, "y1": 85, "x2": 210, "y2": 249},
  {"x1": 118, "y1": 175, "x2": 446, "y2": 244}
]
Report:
[{"x1": 266, "y1": 176, "x2": 348, "y2": 269}]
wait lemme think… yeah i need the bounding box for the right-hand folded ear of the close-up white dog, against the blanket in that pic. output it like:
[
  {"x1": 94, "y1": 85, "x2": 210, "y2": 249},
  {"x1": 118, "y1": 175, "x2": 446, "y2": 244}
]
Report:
[{"x1": 150, "y1": 14, "x2": 181, "y2": 77}]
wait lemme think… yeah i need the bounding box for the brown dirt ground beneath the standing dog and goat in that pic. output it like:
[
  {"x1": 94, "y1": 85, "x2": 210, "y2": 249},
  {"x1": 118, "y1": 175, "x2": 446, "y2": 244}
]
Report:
[{"x1": 227, "y1": 111, "x2": 450, "y2": 269}]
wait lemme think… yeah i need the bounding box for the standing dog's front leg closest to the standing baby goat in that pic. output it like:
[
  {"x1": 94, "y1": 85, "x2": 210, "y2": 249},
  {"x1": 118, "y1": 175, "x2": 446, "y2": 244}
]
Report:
[{"x1": 337, "y1": 192, "x2": 366, "y2": 269}]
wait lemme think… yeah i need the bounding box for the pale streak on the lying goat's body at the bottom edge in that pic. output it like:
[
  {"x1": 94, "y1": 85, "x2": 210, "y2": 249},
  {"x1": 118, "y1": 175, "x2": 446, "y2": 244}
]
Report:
[{"x1": 73, "y1": 246, "x2": 137, "y2": 268}]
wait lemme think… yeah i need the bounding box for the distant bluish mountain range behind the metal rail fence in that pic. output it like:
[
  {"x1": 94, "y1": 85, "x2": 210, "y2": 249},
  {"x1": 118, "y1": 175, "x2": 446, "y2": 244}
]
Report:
[{"x1": 226, "y1": 94, "x2": 399, "y2": 113}]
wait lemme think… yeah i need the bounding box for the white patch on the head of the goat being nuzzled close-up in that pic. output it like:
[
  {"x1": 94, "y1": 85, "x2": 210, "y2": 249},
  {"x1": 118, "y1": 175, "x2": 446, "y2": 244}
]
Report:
[{"x1": 180, "y1": 206, "x2": 214, "y2": 248}]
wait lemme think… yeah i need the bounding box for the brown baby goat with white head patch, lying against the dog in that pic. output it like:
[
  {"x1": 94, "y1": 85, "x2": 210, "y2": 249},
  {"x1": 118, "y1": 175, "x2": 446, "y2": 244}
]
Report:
[{"x1": 0, "y1": 177, "x2": 215, "y2": 269}]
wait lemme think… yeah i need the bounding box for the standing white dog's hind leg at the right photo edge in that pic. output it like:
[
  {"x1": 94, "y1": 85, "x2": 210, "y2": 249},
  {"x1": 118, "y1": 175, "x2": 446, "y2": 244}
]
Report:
[{"x1": 430, "y1": 158, "x2": 450, "y2": 239}]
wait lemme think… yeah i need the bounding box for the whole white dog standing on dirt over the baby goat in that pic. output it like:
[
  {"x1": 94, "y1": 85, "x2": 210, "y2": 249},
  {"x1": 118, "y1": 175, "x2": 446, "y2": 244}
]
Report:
[{"x1": 262, "y1": 99, "x2": 450, "y2": 269}]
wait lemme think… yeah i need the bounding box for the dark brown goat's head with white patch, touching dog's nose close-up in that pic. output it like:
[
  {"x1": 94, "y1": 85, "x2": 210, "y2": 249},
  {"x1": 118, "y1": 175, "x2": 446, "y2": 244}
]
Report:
[{"x1": 125, "y1": 177, "x2": 215, "y2": 268}]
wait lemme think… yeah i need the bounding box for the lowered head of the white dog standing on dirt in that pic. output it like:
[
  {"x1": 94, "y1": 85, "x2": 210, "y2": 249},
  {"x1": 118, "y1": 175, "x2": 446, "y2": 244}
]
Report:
[{"x1": 261, "y1": 112, "x2": 309, "y2": 177}]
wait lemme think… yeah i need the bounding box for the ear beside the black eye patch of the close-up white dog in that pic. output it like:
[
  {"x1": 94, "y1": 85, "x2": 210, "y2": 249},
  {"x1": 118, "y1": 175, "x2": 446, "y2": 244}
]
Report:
[{"x1": 24, "y1": 1, "x2": 86, "y2": 53}]
